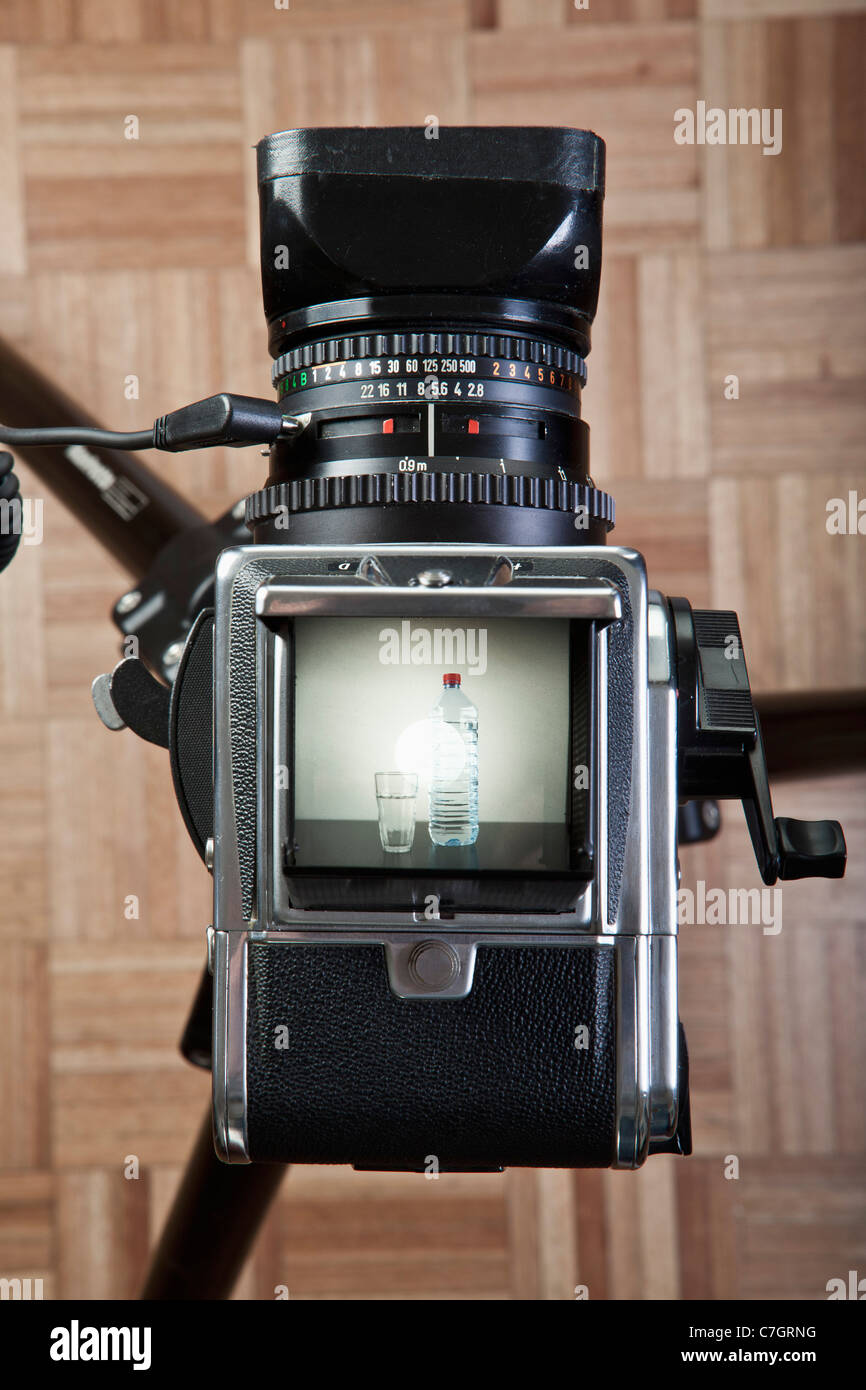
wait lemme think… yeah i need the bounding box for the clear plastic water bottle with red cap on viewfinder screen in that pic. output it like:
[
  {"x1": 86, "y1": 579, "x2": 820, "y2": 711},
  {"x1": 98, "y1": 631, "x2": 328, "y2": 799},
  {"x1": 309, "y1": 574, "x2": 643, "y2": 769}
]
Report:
[{"x1": 430, "y1": 674, "x2": 478, "y2": 845}]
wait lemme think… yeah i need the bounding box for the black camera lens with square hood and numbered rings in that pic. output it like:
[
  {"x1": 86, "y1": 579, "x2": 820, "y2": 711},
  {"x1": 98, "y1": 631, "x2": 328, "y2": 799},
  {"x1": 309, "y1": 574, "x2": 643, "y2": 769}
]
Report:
[{"x1": 247, "y1": 128, "x2": 613, "y2": 543}]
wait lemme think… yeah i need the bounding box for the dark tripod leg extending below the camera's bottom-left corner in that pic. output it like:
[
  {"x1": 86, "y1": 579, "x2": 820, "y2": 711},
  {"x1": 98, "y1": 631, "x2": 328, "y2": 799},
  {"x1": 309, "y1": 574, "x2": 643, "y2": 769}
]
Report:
[{"x1": 140, "y1": 1112, "x2": 288, "y2": 1301}]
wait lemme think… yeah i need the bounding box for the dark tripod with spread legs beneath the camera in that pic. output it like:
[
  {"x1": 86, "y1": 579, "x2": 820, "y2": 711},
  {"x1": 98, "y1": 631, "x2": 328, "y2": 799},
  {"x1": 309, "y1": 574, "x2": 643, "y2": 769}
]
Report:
[{"x1": 0, "y1": 333, "x2": 866, "y2": 1300}]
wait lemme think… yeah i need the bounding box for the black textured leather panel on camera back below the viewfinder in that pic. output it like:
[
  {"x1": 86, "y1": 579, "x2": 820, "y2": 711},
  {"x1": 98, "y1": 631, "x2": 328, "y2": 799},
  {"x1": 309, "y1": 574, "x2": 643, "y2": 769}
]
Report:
[{"x1": 247, "y1": 942, "x2": 616, "y2": 1172}]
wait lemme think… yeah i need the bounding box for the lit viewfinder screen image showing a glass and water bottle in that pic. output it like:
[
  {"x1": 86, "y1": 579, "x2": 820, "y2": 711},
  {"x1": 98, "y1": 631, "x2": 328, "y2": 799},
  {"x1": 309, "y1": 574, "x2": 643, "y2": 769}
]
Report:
[{"x1": 289, "y1": 617, "x2": 571, "y2": 889}]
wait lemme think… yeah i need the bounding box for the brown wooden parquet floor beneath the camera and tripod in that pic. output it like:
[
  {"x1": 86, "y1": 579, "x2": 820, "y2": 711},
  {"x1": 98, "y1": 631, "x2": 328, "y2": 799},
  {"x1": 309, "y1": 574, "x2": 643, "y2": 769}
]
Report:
[{"x1": 0, "y1": 0, "x2": 866, "y2": 1300}]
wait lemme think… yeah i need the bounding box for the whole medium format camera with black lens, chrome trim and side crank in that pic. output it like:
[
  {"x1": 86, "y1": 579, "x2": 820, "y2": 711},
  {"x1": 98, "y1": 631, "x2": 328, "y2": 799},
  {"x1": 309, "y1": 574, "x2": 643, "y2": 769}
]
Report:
[{"x1": 161, "y1": 128, "x2": 845, "y2": 1172}]
